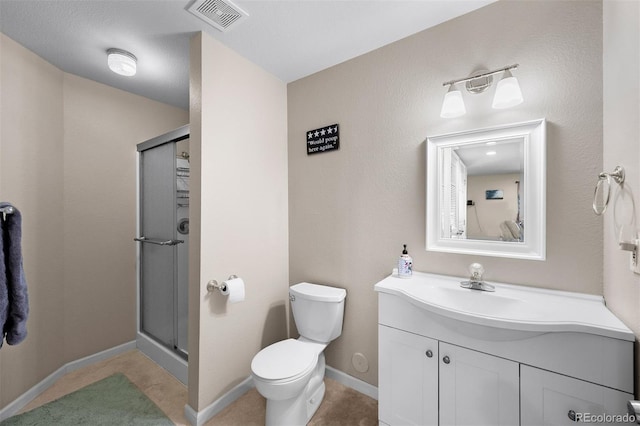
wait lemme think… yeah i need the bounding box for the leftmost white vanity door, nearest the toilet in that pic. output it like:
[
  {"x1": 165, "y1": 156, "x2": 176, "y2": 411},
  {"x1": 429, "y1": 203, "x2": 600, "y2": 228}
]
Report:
[{"x1": 378, "y1": 325, "x2": 438, "y2": 426}]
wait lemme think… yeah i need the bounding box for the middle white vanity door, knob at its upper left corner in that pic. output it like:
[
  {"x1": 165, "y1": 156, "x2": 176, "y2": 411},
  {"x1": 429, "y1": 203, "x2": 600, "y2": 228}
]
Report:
[{"x1": 439, "y1": 342, "x2": 520, "y2": 426}]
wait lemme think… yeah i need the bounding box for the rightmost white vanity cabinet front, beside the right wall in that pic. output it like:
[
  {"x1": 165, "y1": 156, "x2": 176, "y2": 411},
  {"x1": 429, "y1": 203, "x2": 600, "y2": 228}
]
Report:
[{"x1": 520, "y1": 365, "x2": 633, "y2": 426}]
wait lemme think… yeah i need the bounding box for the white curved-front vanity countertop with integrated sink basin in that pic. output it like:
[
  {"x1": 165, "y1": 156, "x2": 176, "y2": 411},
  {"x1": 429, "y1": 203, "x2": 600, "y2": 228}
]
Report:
[{"x1": 374, "y1": 272, "x2": 635, "y2": 341}]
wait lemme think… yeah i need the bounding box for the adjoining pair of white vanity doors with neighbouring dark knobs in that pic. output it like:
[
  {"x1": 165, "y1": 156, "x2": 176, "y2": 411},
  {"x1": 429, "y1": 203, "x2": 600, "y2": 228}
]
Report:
[{"x1": 378, "y1": 325, "x2": 519, "y2": 426}]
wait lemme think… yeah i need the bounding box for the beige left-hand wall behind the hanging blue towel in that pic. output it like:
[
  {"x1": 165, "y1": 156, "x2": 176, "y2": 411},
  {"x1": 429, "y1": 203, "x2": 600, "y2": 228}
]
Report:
[{"x1": 0, "y1": 34, "x2": 66, "y2": 407}]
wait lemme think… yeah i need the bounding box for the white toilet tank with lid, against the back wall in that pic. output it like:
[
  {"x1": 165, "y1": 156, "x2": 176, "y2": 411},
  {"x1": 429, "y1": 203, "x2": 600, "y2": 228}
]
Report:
[{"x1": 289, "y1": 283, "x2": 347, "y2": 343}]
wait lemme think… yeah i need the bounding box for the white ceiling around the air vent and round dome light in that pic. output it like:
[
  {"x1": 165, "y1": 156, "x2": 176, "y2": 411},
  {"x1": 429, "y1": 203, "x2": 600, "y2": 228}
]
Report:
[{"x1": 0, "y1": 0, "x2": 495, "y2": 109}]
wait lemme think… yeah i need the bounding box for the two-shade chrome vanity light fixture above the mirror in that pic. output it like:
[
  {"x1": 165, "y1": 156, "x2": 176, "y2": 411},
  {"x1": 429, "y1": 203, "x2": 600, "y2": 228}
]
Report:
[{"x1": 440, "y1": 64, "x2": 523, "y2": 118}]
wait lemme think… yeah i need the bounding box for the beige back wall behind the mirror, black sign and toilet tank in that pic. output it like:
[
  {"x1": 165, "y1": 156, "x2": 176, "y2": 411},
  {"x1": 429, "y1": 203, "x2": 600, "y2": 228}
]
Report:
[{"x1": 288, "y1": 1, "x2": 602, "y2": 384}]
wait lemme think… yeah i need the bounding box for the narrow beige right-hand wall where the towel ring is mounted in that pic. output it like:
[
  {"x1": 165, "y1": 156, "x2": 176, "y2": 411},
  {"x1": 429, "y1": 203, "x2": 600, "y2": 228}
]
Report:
[{"x1": 603, "y1": 0, "x2": 640, "y2": 396}]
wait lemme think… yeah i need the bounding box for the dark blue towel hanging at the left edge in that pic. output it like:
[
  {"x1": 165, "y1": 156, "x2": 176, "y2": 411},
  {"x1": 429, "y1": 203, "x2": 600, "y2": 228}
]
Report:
[{"x1": 0, "y1": 203, "x2": 29, "y2": 347}]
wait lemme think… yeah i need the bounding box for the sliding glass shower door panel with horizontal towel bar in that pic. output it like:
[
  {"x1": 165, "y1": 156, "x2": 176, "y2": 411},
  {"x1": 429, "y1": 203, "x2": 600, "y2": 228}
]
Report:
[{"x1": 136, "y1": 143, "x2": 186, "y2": 357}]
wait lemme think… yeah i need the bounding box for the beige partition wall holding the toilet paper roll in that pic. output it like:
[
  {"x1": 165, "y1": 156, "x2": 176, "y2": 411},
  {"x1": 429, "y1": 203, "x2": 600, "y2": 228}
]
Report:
[{"x1": 189, "y1": 34, "x2": 289, "y2": 410}]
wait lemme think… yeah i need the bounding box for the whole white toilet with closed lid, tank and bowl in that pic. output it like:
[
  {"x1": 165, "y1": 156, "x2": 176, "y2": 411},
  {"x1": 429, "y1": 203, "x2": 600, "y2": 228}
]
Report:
[{"x1": 251, "y1": 283, "x2": 347, "y2": 426}]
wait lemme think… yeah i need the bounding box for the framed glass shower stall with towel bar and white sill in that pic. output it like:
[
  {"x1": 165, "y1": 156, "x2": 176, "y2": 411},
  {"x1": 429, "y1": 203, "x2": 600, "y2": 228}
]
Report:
[{"x1": 134, "y1": 125, "x2": 190, "y2": 384}]
